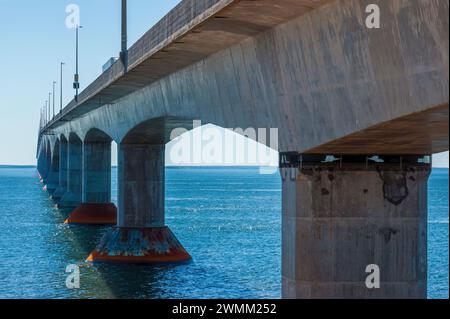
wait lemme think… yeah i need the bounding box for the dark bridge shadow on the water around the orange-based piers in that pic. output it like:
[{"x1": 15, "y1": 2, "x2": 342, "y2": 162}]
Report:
[{"x1": 50, "y1": 209, "x2": 177, "y2": 299}]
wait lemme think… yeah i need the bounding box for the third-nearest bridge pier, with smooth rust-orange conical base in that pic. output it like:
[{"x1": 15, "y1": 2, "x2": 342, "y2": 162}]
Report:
[{"x1": 65, "y1": 140, "x2": 117, "y2": 225}]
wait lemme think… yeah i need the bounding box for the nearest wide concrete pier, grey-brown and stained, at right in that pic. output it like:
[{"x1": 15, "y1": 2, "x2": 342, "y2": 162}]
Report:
[{"x1": 280, "y1": 153, "x2": 431, "y2": 299}]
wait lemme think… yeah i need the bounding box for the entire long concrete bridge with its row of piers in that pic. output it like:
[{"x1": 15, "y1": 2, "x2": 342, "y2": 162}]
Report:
[{"x1": 37, "y1": 0, "x2": 449, "y2": 298}]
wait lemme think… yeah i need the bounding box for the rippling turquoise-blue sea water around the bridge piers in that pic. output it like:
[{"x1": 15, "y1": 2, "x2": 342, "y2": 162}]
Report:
[{"x1": 0, "y1": 168, "x2": 449, "y2": 298}]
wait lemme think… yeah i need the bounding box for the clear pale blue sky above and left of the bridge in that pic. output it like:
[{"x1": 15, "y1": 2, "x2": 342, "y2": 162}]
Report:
[{"x1": 0, "y1": 0, "x2": 448, "y2": 167}]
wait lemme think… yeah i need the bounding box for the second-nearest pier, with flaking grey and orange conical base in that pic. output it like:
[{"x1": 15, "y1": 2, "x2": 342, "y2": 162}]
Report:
[{"x1": 88, "y1": 144, "x2": 191, "y2": 263}]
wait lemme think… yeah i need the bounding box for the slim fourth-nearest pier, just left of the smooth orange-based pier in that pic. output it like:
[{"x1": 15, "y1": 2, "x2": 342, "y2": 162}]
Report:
[{"x1": 58, "y1": 134, "x2": 83, "y2": 208}]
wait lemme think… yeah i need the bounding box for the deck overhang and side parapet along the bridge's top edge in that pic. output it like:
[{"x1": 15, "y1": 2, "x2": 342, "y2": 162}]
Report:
[{"x1": 54, "y1": 0, "x2": 331, "y2": 122}]
